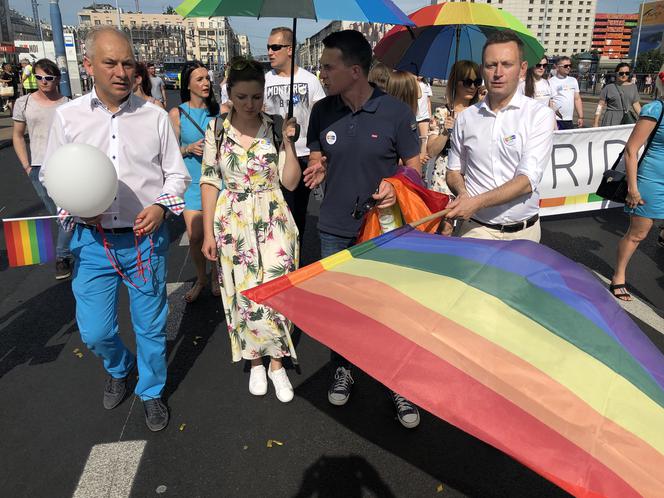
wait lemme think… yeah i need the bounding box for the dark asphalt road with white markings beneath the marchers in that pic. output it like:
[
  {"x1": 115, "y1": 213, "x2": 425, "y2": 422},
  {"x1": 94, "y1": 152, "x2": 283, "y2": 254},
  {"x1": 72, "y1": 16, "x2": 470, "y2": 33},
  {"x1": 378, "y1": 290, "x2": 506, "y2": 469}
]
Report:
[{"x1": 0, "y1": 89, "x2": 664, "y2": 498}]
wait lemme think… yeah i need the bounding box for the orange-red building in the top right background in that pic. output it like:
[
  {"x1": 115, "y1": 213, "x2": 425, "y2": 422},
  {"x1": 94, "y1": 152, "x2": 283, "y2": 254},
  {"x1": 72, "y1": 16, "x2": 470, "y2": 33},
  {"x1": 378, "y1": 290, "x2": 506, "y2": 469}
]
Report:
[{"x1": 591, "y1": 14, "x2": 639, "y2": 59}]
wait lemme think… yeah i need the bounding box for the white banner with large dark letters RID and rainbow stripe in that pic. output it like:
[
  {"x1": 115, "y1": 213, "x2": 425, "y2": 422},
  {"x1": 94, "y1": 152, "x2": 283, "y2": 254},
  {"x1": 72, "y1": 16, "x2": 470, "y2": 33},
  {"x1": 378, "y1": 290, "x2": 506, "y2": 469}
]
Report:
[{"x1": 539, "y1": 125, "x2": 634, "y2": 216}]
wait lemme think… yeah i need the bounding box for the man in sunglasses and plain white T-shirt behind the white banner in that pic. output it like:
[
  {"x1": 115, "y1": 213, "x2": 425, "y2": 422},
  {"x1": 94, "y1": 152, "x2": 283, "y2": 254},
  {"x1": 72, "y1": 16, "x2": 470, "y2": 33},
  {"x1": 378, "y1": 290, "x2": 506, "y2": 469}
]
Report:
[{"x1": 549, "y1": 56, "x2": 583, "y2": 130}]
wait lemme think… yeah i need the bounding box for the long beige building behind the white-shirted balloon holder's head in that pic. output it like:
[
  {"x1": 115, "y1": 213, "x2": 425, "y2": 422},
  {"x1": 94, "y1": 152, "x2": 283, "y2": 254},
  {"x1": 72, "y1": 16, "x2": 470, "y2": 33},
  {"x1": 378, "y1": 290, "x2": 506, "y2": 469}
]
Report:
[{"x1": 78, "y1": 3, "x2": 240, "y2": 69}]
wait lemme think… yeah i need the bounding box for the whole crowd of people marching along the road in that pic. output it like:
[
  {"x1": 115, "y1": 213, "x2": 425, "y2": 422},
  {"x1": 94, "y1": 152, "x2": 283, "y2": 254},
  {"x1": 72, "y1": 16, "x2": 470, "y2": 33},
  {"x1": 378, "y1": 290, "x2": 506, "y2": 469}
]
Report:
[{"x1": 6, "y1": 26, "x2": 664, "y2": 431}]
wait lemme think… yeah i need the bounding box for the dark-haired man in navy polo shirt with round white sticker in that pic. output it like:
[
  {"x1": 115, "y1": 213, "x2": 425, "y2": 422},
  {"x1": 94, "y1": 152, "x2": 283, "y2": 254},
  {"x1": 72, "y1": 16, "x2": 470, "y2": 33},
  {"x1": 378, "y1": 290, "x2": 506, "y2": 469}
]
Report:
[{"x1": 304, "y1": 30, "x2": 420, "y2": 428}]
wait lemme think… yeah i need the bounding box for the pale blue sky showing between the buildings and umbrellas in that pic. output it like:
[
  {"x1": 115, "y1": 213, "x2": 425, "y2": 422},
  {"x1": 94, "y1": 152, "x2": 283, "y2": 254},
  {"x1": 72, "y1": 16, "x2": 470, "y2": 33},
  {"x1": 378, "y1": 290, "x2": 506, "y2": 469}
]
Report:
[{"x1": 9, "y1": 0, "x2": 641, "y2": 54}]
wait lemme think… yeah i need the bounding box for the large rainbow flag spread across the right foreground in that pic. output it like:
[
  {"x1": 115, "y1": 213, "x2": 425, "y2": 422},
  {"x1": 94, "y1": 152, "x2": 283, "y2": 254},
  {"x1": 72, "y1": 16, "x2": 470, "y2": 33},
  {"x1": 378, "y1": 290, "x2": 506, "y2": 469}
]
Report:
[{"x1": 245, "y1": 226, "x2": 664, "y2": 498}]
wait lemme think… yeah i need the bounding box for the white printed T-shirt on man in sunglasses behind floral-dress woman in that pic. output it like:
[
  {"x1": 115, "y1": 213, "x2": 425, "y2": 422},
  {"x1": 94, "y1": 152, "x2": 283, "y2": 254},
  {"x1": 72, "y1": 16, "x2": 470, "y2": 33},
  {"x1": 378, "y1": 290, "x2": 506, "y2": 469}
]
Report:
[{"x1": 264, "y1": 67, "x2": 325, "y2": 157}]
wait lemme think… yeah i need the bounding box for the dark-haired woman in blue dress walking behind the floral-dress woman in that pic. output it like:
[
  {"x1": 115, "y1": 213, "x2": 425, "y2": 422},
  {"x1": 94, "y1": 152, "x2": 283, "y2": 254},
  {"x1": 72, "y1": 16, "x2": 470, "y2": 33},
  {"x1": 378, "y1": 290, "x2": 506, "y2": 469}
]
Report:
[{"x1": 168, "y1": 61, "x2": 220, "y2": 303}]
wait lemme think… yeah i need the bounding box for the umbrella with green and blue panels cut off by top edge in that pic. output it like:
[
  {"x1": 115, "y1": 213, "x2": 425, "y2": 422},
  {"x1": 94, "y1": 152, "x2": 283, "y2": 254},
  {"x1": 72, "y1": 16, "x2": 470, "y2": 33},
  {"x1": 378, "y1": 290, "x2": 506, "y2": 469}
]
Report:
[{"x1": 175, "y1": 0, "x2": 413, "y2": 120}]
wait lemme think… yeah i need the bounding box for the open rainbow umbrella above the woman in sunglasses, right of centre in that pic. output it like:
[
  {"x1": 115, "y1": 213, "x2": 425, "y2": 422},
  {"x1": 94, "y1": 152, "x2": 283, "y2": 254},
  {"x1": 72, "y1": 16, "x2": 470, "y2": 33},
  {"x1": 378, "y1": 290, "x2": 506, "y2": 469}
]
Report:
[{"x1": 374, "y1": 2, "x2": 544, "y2": 79}]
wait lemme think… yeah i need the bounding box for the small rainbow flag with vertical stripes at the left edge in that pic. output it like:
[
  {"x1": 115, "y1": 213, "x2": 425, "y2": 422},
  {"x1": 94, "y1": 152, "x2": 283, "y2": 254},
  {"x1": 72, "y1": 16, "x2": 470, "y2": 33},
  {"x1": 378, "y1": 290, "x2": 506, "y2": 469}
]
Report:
[{"x1": 2, "y1": 216, "x2": 55, "y2": 266}]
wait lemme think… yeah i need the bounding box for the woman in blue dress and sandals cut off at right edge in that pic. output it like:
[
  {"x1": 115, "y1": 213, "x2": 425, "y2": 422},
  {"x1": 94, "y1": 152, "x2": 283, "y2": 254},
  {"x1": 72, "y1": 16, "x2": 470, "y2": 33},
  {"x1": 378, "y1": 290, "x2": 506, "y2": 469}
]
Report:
[{"x1": 609, "y1": 66, "x2": 664, "y2": 301}]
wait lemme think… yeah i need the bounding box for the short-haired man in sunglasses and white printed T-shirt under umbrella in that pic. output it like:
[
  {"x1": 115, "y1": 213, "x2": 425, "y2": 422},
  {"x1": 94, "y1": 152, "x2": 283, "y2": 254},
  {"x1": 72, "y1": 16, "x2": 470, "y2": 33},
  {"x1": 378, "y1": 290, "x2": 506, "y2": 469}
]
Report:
[{"x1": 264, "y1": 27, "x2": 325, "y2": 241}]
